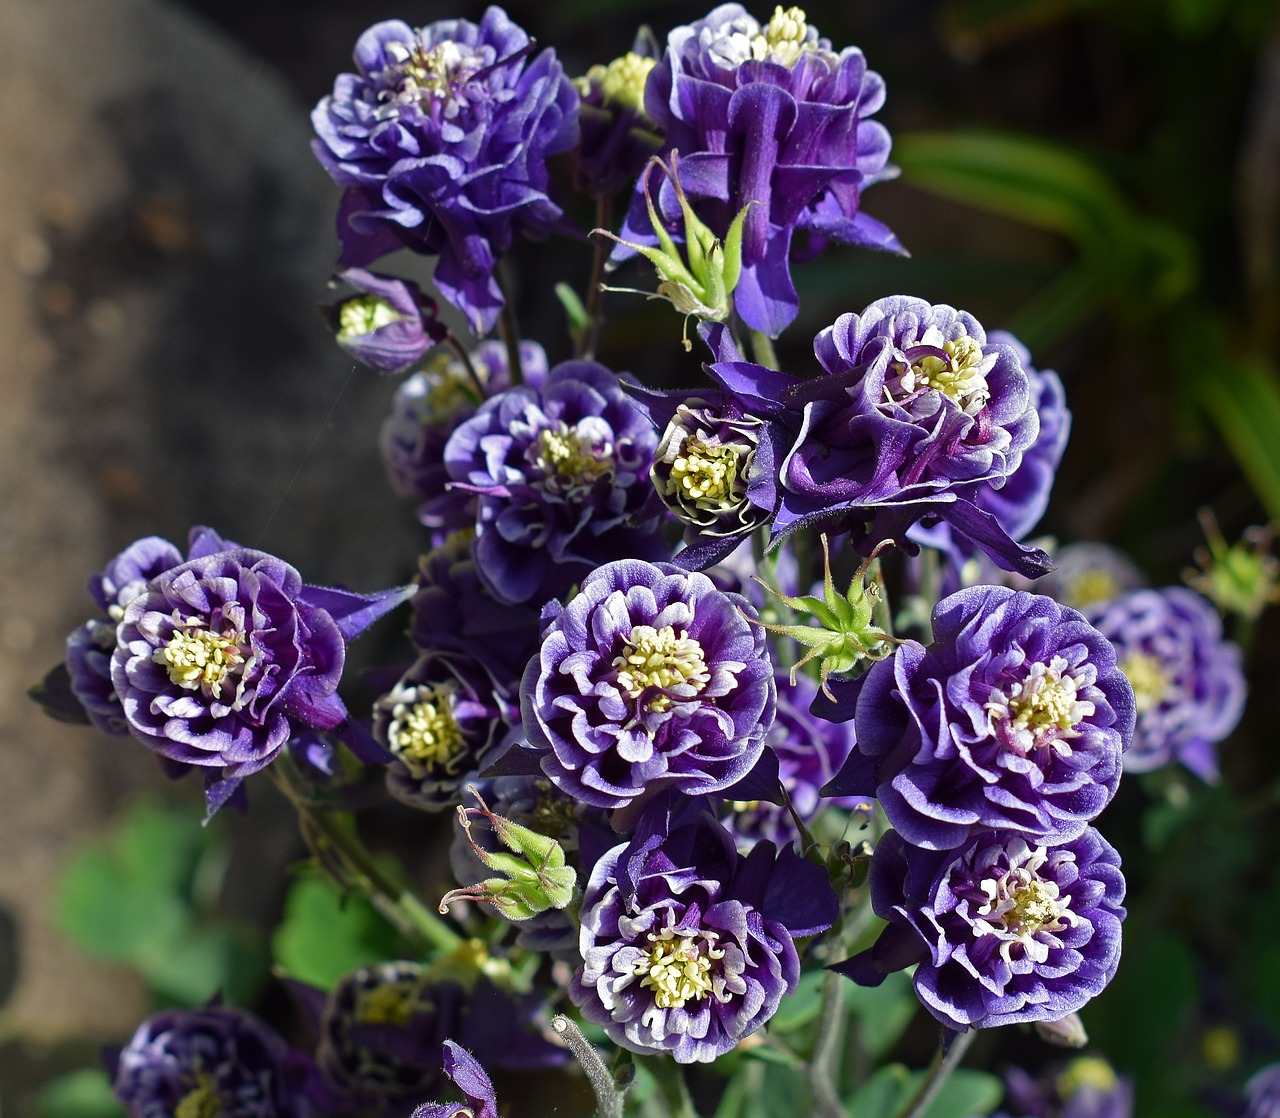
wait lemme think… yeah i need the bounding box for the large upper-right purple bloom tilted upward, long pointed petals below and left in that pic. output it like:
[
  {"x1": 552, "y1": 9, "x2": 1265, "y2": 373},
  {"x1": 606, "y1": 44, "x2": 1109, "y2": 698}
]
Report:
[{"x1": 747, "y1": 296, "x2": 1048, "y2": 576}]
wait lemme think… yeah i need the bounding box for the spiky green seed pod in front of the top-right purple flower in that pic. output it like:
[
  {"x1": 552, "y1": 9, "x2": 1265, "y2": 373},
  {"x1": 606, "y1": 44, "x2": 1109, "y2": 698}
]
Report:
[{"x1": 591, "y1": 151, "x2": 754, "y2": 350}]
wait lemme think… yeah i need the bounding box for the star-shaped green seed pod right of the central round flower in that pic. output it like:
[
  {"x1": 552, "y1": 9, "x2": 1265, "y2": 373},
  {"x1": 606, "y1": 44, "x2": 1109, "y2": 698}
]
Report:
[{"x1": 756, "y1": 534, "x2": 897, "y2": 698}]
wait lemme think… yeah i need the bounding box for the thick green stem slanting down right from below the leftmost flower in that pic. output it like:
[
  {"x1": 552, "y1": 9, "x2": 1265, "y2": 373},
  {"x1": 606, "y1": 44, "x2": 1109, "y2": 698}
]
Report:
[{"x1": 270, "y1": 761, "x2": 463, "y2": 952}]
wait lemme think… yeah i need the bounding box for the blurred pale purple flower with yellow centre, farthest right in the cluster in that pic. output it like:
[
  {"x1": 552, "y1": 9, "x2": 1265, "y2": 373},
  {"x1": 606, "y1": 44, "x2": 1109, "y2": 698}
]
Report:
[{"x1": 1084, "y1": 587, "x2": 1247, "y2": 781}]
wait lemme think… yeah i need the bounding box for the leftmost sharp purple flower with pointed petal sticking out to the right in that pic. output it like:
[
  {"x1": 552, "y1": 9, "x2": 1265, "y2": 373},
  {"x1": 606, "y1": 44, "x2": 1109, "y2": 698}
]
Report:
[{"x1": 111, "y1": 548, "x2": 412, "y2": 811}]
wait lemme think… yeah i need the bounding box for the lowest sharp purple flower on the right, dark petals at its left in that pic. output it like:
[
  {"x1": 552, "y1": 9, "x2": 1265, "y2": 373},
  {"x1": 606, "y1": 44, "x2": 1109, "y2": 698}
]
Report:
[{"x1": 835, "y1": 827, "x2": 1125, "y2": 1031}]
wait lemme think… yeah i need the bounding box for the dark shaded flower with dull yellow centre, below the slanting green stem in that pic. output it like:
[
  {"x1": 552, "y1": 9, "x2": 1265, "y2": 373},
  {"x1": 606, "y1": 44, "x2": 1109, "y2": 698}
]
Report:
[{"x1": 316, "y1": 962, "x2": 563, "y2": 1106}]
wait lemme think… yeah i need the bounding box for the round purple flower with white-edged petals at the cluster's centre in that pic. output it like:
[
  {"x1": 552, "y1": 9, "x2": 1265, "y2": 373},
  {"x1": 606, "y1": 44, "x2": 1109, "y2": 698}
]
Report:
[{"x1": 521, "y1": 560, "x2": 776, "y2": 809}]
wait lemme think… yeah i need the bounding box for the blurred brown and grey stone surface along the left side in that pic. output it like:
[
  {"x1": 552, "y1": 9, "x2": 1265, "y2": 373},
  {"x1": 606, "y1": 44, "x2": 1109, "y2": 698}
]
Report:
[{"x1": 0, "y1": 0, "x2": 421, "y2": 1041}]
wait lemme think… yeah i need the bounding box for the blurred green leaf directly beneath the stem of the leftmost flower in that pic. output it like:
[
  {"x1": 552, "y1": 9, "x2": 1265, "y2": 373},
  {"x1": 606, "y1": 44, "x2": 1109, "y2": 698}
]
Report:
[{"x1": 271, "y1": 876, "x2": 399, "y2": 990}]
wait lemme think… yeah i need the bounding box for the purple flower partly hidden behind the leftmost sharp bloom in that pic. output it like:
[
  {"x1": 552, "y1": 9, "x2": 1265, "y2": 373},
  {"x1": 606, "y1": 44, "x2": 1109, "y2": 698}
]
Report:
[{"x1": 67, "y1": 528, "x2": 236, "y2": 735}]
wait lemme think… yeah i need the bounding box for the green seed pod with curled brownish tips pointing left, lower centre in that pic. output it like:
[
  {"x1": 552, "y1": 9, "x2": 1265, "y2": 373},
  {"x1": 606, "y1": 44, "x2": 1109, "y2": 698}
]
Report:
[{"x1": 440, "y1": 785, "x2": 577, "y2": 921}]
